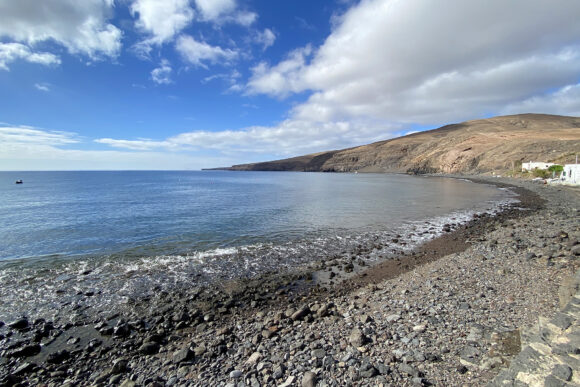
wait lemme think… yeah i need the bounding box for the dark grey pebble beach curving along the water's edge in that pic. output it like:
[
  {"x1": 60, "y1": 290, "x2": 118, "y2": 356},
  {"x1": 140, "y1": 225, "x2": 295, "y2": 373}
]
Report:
[{"x1": 0, "y1": 176, "x2": 580, "y2": 386}]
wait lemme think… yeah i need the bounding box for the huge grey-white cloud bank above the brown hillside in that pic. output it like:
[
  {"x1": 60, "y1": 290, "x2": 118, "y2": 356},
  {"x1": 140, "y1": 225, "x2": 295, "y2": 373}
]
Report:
[{"x1": 246, "y1": 0, "x2": 580, "y2": 124}]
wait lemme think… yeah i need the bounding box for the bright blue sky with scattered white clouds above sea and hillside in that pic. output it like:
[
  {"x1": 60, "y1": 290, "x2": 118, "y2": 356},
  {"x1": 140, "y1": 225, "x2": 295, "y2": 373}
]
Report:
[{"x1": 0, "y1": 0, "x2": 580, "y2": 170}]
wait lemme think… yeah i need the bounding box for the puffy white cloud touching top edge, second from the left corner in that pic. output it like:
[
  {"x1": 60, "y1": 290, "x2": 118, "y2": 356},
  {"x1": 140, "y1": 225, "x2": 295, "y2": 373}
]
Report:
[{"x1": 130, "y1": 0, "x2": 195, "y2": 55}]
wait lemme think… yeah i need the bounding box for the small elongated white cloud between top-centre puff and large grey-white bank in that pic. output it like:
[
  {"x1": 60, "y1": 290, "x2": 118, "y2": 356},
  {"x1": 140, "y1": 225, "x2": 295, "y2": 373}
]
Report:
[{"x1": 176, "y1": 35, "x2": 238, "y2": 67}]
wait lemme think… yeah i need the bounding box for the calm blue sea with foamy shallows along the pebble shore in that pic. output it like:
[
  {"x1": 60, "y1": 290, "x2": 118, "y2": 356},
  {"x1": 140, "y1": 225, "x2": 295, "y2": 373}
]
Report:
[{"x1": 0, "y1": 171, "x2": 515, "y2": 321}]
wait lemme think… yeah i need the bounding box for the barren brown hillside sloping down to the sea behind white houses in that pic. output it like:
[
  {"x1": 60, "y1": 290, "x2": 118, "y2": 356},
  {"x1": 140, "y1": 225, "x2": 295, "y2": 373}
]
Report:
[{"x1": 229, "y1": 114, "x2": 580, "y2": 173}]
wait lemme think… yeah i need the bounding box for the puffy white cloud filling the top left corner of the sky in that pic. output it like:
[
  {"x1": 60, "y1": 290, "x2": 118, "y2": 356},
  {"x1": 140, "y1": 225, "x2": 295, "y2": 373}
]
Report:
[{"x1": 0, "y1": 0, "x2": 122, "y2": 63}]
